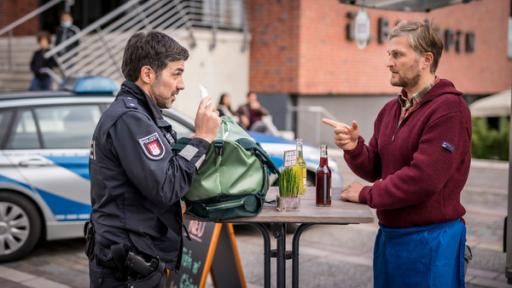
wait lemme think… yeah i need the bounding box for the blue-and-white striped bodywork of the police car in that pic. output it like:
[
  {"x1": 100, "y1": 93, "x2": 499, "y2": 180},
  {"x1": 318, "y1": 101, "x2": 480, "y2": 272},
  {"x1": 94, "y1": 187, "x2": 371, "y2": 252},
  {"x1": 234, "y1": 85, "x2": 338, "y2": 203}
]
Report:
[{"x1": 0, "y1": 133, "x2": 337, "y2": 226}]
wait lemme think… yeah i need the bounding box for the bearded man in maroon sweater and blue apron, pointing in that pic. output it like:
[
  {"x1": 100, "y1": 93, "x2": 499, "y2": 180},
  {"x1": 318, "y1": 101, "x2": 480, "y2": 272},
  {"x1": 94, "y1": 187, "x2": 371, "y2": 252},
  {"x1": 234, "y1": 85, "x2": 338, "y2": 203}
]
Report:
[{"x1": 323, "y1": 21, "x2": 471, "y2": 287}]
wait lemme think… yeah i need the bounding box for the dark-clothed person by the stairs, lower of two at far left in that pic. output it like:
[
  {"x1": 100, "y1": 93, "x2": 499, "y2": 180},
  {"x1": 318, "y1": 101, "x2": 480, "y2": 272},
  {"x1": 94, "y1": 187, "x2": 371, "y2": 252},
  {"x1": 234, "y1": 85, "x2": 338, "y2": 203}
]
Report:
[{"x1": 29, "y1": 31, "x2": 57, "y2": 91}]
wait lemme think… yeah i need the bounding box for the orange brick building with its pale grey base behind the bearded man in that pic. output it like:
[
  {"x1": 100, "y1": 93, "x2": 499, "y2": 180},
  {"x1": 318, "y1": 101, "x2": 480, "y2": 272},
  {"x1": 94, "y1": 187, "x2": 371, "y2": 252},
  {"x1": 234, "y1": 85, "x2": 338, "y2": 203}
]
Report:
[{"x1": 249, "y1": 0, "x2": 512, "y2": 142}]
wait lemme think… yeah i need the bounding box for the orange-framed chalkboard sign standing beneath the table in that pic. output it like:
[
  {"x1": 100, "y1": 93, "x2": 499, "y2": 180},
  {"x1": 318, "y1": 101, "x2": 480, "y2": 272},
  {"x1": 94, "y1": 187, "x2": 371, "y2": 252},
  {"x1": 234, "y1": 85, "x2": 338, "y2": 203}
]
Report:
[{"x1": 171, "y1": 219, "x2": 247, "y2": 288}]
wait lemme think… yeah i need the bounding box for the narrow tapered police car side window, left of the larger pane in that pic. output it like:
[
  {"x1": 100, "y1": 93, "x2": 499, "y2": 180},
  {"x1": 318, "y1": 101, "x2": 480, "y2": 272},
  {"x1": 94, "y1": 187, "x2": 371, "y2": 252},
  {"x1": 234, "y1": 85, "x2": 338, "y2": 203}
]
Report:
[{"x1": 7, "y1": 110, "x2": 40, "y2": 149}]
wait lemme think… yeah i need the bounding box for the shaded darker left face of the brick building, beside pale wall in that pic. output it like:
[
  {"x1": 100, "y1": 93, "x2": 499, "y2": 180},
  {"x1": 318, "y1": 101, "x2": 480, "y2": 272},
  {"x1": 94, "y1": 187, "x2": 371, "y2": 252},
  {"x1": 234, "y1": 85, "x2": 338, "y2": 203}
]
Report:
[{"x1": 247, "y1": 0, "x2": 300, "y2": 93}]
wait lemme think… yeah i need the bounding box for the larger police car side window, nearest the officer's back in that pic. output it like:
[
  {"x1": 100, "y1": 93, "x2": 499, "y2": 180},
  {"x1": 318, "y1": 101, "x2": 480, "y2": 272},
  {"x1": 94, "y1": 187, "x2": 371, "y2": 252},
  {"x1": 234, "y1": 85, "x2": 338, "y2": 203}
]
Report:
[{"x1": 35, "y1": 105, "x2": 101, "y2": 149}]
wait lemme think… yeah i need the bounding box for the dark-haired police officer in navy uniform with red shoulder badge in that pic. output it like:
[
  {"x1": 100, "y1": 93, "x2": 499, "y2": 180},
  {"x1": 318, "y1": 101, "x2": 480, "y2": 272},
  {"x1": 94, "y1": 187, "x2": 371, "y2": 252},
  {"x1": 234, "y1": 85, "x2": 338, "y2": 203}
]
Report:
[{"x1": 86, "y1": 31, "x2": 220, "y2": 287}]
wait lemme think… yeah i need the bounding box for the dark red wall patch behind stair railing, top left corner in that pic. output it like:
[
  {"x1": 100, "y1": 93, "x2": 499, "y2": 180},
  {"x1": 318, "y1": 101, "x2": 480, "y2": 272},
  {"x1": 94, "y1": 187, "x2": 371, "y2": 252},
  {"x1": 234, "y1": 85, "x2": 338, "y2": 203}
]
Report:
[{"x1": 0, "y1": 0, "x2": 39, "y2": 37}]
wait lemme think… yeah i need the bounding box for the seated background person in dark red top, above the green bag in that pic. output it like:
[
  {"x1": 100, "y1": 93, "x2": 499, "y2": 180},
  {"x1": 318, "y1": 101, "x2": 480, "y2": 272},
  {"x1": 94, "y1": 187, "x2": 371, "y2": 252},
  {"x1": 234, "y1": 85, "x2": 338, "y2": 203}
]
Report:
[{"x1": 237, "y1": 91, "x2": 269, "y2": 132}]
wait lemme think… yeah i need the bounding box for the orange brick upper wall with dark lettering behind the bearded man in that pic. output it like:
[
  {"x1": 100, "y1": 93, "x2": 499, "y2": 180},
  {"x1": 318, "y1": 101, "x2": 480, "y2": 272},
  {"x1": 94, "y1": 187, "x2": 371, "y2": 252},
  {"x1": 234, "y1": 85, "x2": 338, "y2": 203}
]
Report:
[{"x1": 249, "y1": 0, "x2": 512, "y2": 95}]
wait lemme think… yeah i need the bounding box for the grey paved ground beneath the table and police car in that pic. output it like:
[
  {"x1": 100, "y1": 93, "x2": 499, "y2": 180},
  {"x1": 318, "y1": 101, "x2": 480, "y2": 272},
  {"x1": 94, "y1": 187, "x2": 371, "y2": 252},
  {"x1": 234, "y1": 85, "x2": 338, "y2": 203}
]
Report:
[{"x1": 0, "y1": 161, "x2": 512, "y2": 288}]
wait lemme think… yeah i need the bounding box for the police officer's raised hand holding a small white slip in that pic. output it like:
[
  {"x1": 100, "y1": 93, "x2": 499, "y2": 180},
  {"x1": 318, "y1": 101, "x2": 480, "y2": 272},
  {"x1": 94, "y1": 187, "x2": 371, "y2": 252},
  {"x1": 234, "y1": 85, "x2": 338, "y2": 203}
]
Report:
[{"x1": 195, "y1": 96, "x2": 220, "y2": 143}]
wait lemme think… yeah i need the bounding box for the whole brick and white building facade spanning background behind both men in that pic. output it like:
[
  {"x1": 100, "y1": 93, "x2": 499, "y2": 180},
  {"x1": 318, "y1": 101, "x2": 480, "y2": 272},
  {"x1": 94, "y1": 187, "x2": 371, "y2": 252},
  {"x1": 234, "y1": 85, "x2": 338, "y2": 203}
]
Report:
[{"x1": 0, "y1": 0, "x2": 512, "y2": 144}]
